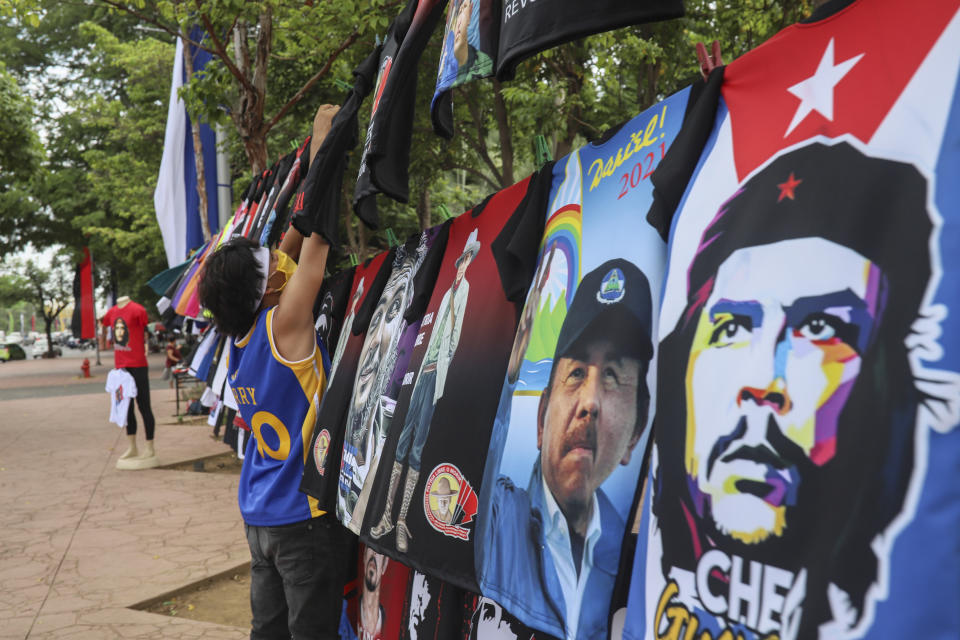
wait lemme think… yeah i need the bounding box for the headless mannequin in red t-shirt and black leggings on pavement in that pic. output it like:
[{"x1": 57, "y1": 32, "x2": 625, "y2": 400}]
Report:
[{"x1": 100, "y1": 296, "x2": 159, "y2": 469}]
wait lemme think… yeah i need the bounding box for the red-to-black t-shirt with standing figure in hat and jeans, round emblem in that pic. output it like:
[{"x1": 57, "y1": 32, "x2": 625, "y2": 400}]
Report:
[{"x1": 361, "y1": 166, "x2": 549, "y2": 587}]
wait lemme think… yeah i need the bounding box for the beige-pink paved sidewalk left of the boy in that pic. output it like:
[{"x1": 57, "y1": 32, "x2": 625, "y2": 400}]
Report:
[{"x1": 0, "y1": 353, "x2": 250, "y2": 640}]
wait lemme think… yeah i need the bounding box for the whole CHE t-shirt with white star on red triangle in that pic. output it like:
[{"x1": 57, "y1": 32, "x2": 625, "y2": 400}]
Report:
[{"x1": 624, "y1": 0, "x2": 960, "y2": 640}]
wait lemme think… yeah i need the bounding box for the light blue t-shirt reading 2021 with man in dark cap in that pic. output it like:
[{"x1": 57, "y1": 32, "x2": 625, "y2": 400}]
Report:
[{"x1": 476, "y1": 89, "x2": 691, "y2": 640}]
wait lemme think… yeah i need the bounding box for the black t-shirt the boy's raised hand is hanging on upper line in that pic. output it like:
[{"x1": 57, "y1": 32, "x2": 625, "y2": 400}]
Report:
[{"x1": 294, "y1": 47, "x2": 380, "y2": 246}]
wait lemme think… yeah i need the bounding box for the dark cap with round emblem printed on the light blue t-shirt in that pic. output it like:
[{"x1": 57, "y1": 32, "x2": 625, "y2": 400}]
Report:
[{"x1": 553, "y1": 258, "x2": 653, "y2": 368}]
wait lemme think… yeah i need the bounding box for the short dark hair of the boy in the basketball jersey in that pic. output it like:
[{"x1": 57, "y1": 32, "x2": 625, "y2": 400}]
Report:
[{"x1": 198, "y1": 236, "x2": 263, "y2": 337}]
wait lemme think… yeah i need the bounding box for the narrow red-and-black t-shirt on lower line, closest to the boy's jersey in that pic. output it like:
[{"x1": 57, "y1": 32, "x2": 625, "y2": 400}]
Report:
[{"x1": 300, "y1": 250, "x2": 394, "y2": 513}]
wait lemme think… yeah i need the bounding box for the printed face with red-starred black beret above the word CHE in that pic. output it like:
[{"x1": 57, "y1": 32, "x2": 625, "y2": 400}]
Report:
[{"x1": 647, "y1": 141, "x2": 957, "y2": 638}]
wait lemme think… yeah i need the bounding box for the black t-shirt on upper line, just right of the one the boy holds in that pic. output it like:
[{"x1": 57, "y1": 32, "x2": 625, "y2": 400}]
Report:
[{"x1": 355, "y1": 0, "x2": 454, "y2": 228}]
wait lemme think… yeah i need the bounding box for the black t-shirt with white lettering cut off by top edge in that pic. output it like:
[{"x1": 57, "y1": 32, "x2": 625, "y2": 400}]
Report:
[{"x1": 497, "y1": 0, "x2": 683, "y2": 80}]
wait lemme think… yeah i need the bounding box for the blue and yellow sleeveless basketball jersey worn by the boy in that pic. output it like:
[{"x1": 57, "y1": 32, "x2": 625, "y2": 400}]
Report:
[{"x1": 228, "y1": 307, "x2": 327, "y2": 526}]
